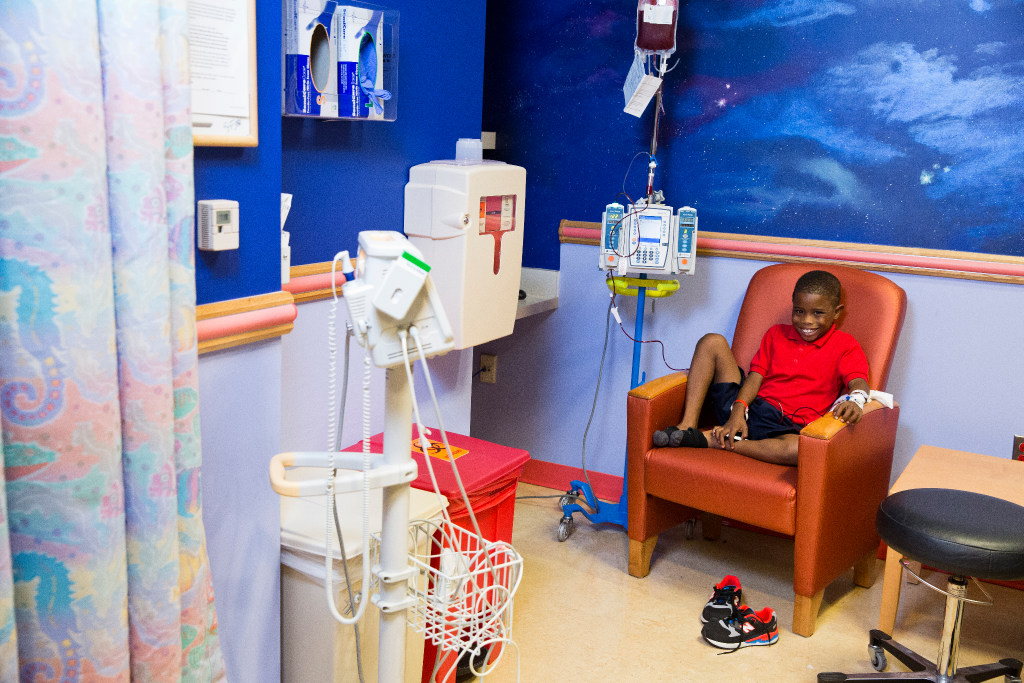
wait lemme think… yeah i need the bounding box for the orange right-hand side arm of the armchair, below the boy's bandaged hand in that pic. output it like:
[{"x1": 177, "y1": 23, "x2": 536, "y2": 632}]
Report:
[{"x1": 794, "y1": 402, "x2": 899, "y2": 595}]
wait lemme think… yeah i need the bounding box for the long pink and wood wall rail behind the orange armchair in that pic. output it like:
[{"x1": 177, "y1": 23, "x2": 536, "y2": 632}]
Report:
[{"x1": 558, "y1": 220, "x2": 1024, "y2": 285}]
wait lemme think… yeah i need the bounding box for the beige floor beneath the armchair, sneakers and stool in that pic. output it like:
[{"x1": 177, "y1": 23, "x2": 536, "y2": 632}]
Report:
[{"x1": 483, "y1": 484, "x2": 1024, "y2": 683}]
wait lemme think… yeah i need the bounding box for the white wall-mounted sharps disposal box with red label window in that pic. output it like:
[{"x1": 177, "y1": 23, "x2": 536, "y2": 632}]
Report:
[{"x1": 406, "y1": 140, "x2": 526, "y2": 349}]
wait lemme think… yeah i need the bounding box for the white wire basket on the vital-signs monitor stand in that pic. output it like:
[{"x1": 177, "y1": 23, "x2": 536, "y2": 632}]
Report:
[{"x1": 373, "y1": 519, "x2": 522, "y2": 673}]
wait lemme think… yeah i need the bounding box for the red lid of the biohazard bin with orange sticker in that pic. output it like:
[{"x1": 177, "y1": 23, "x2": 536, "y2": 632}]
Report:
[{"x1": 345, "y1": 425, "x2": 529, "y2": 498}]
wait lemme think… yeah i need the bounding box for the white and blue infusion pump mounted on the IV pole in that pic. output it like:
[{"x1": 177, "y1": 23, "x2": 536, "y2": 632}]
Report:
[{"x1": 598, "y1": 202, "x2": 697, "y2": 275}]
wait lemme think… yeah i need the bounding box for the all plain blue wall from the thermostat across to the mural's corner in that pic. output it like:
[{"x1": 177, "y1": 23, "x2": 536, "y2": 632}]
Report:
[{"x1": 196, "y1": 0, "x2": 485, "y2": 304}]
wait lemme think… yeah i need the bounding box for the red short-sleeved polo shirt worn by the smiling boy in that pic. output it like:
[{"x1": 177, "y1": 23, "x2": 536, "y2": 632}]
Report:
[{"x1": 751, "y1": 325, "x2": 867, "y2": 425}]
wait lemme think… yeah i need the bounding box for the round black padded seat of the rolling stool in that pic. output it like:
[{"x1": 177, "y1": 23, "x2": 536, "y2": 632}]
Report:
[{"x1": 876, "y1": 488, "x2": 1024, "y2": 581}]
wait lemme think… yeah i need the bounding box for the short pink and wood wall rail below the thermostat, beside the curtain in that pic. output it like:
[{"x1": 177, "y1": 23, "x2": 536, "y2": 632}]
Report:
[{"x1": 196, "y1": 292, "x2": 298, "y2": 353}]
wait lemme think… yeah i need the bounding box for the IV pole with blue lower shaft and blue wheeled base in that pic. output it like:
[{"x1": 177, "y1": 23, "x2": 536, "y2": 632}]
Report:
[{"x1": 558, "y1": 57, "x2": 668, "y2": 541}]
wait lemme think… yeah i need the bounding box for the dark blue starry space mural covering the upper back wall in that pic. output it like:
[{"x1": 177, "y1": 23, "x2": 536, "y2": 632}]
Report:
[{"x1": 483, "y1": 0, "x2": 1024, "y2": 267}]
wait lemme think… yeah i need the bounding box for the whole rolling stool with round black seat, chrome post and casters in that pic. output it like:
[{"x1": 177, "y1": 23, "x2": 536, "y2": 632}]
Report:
[{"x1": 818, "y1": 488, "x2": 1024, "y2": 683}]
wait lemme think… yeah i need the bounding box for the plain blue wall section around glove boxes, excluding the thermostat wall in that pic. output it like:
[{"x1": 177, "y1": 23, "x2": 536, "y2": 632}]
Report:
[{"x1": 278, "y1": 0, "x2": 485, "y2": 265}]
